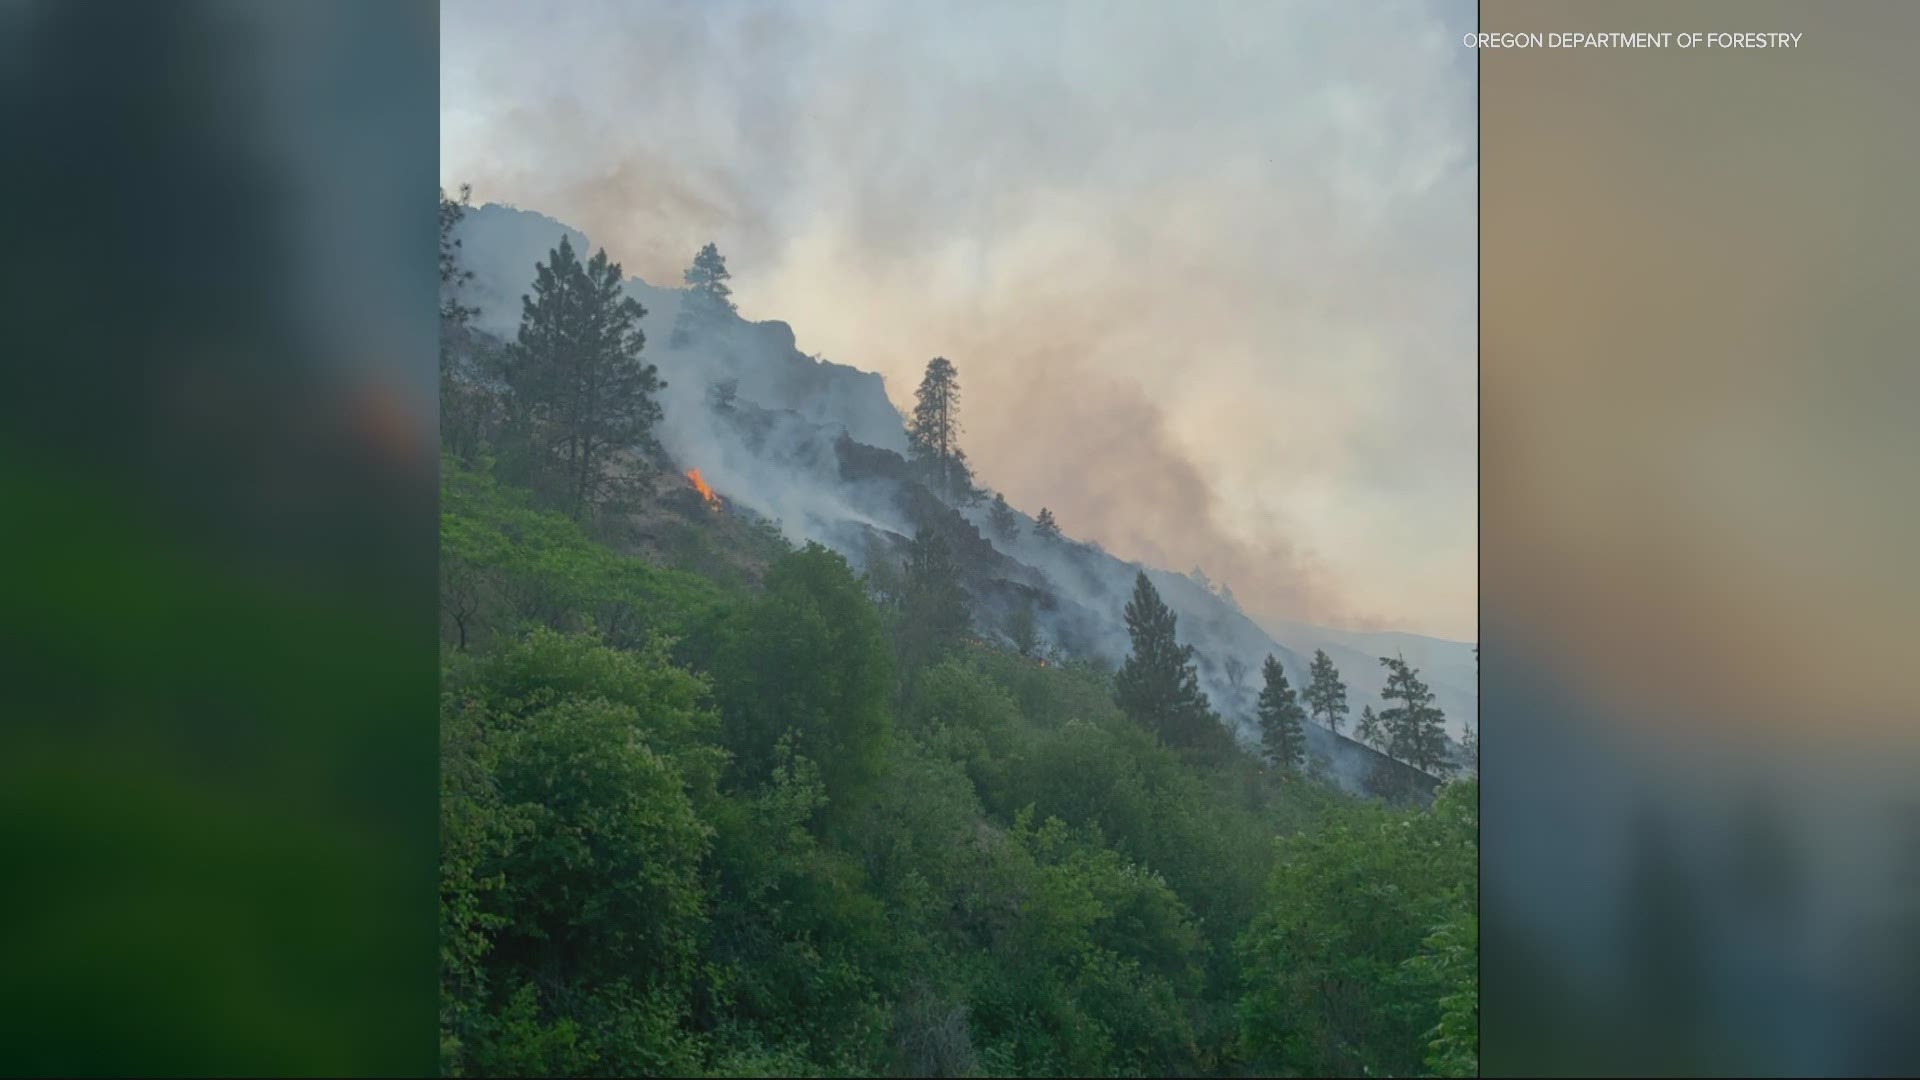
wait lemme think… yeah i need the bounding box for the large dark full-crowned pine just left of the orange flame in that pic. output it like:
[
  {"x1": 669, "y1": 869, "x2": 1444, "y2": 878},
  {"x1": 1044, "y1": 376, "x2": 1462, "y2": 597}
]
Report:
[{"x1": 507, "y1": 236, "x2": 664, "y2": 519}]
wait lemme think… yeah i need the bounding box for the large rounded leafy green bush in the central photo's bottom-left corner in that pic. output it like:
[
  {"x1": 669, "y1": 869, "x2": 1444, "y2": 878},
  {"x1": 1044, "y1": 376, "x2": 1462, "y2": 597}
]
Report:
[{"x1": 442, "y1": 630, "x2": 720, "y2": 1074}]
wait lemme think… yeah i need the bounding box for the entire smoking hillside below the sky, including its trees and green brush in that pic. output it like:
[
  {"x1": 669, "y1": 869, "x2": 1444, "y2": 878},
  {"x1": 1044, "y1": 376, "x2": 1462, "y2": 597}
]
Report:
[{"x1": 440, "y1": 184, "x2": 1478, "y2": 1076}]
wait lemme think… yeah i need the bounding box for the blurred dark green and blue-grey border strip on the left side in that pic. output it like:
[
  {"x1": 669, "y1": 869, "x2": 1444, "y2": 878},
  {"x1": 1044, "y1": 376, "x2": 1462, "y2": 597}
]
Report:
[{"x1": 0, "y1": 0, "x2": 438, "y2": 1076}]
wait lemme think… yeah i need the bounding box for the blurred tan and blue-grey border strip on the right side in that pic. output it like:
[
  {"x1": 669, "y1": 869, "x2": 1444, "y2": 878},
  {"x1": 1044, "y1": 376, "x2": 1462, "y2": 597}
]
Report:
[{"x1": 1480, "y1": 0, "x2": 1920, "y2": 1076}]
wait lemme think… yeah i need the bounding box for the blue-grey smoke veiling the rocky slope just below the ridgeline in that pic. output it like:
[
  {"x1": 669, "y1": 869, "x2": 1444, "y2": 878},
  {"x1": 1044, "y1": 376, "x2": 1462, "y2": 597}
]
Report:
[{"x1": 445, "y1": 204, "x2": 1471, "y2": 798}]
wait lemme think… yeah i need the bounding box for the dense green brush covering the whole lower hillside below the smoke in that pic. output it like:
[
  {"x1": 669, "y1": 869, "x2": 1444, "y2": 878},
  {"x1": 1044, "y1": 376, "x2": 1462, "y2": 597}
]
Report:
[{"x1": 442, "y1": 191, "x2": 1478, "y2": 1076}]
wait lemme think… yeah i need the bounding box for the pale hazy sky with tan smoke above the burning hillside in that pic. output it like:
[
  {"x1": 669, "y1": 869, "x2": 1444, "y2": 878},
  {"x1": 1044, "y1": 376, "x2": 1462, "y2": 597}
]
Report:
[{"x1": 442, "y1": 0, "x2": 1476, "y2": 640}]
